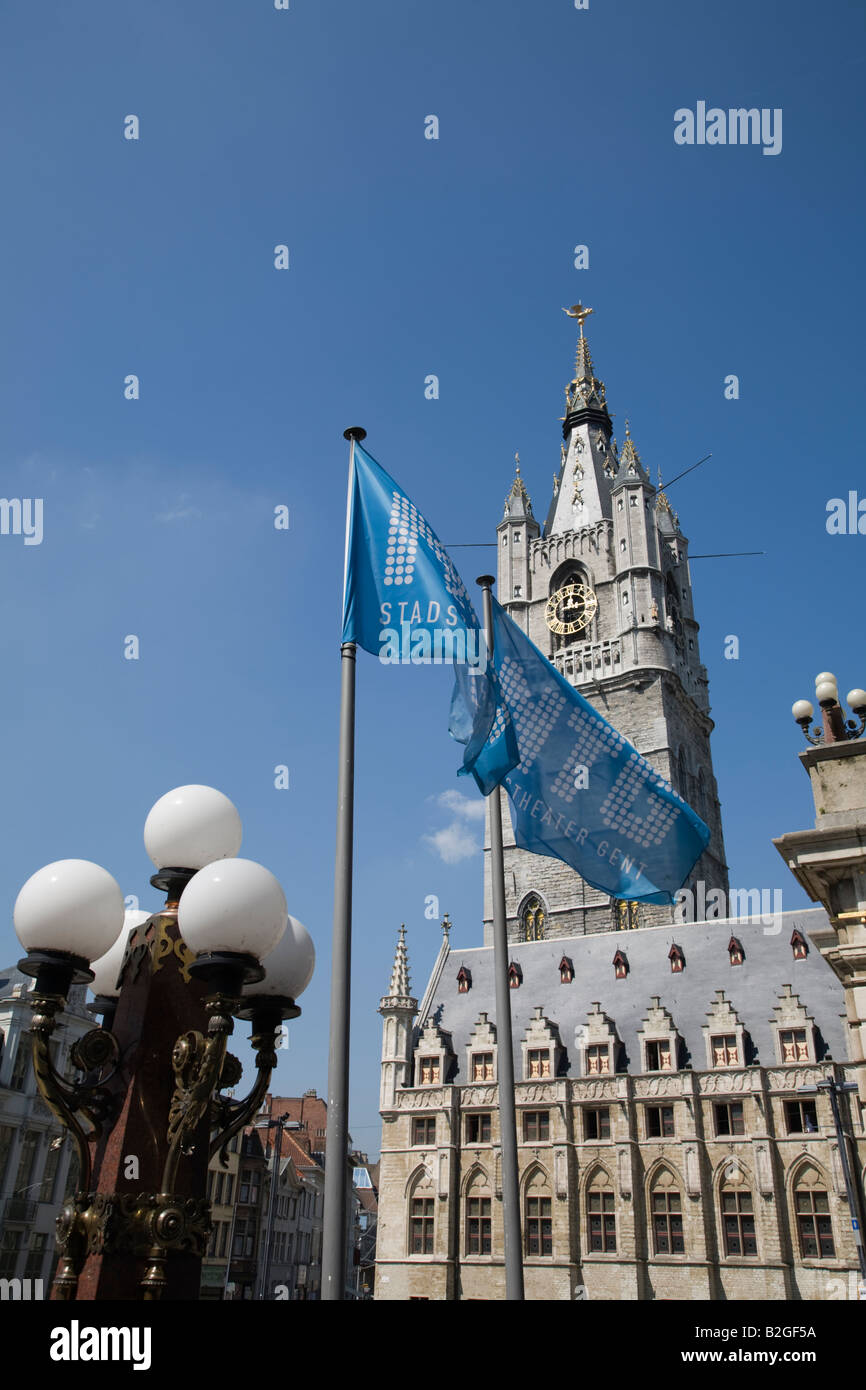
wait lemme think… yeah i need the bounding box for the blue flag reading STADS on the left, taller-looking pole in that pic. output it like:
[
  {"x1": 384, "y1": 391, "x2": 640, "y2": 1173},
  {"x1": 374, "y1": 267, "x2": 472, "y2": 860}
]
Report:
[{"x1": 342, "y1": 443, "x2": 517, "y2": 791}]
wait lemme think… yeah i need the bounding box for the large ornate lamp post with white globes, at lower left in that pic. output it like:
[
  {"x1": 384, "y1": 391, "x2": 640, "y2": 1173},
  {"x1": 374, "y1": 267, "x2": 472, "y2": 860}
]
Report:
[{"x1": 15, "y1": 787, "x2": 314, "y2": 1300}]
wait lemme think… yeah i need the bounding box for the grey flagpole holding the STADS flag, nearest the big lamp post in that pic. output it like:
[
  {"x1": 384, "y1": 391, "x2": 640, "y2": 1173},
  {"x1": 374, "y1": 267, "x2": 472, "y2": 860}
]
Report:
[{"x1": 321, "y1": 425, "x2": 367, "y2": 1302}]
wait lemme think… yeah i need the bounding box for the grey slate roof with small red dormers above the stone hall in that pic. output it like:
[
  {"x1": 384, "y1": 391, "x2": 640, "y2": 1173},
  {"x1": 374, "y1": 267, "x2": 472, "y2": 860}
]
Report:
[{"x1": 416, "y1": 908, "x2": 848, "y2": 1086}]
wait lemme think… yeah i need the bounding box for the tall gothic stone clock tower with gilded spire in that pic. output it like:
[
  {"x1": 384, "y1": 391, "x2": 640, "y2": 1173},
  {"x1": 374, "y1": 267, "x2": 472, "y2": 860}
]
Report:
[{"x1": 484, "y1": 304, "x2": 728, "y2": 944}]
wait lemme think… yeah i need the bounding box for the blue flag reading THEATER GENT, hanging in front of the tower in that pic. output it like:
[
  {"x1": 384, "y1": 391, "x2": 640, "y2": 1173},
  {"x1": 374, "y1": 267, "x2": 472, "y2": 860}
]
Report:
[{"x1": 467, "y1": 600, "x2": 710, "y2": 902}]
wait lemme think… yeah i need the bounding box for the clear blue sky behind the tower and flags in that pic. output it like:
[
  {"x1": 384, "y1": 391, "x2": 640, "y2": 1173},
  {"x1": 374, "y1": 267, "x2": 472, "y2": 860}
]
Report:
[{"x1": 0, "y1": 0, "x2": 866, "y2": 1154}]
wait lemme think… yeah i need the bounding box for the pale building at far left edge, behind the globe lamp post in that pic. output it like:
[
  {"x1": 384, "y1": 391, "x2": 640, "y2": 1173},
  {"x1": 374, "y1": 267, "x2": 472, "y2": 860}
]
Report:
[{"x1": 0, "y1": 966, "x2": 95, "y2": 1297}]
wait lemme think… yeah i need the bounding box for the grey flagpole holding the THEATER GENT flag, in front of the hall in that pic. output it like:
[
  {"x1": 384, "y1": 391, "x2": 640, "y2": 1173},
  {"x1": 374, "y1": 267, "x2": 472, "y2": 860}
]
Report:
[{"x1": 475, "y1": 574, "x2": 524, "y2": 1301}]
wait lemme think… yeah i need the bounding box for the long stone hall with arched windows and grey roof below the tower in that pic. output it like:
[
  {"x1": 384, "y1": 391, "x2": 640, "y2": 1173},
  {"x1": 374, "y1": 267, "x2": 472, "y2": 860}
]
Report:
[{"x1": 375, "y1": 910, "x2": 866, "y2": 1300}]
